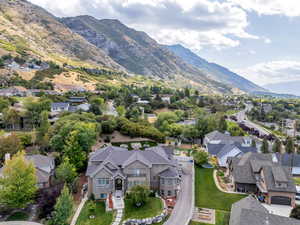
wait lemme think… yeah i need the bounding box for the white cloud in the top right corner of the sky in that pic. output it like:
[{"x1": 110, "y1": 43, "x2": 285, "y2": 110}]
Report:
[{"x1": 229, "y1": 0, "x2": 300, "y2": 17}]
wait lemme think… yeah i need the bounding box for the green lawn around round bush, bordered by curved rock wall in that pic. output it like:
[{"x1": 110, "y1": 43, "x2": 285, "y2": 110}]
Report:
[{"x1": 123, "y1": 197, "x2": 163, "y2": 220}]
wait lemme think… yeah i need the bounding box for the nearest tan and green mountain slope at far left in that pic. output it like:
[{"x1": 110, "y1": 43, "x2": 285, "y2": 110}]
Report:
[{"x1": 0, "y1": 0, "x2": 123, "y2": 70}]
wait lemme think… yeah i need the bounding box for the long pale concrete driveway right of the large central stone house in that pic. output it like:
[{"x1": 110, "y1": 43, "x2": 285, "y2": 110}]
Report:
[{"x1": 164, "y1": 158, "x2": 194, "y2": 225}]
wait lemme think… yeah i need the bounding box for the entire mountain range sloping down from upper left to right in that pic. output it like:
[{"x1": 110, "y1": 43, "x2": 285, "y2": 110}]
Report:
[{"x1": 0, "y1": 0, "x2": 266, "y2": 94}]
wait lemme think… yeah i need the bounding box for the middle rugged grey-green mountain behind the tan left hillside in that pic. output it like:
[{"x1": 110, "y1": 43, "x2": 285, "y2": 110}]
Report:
[{"x1": 61, "y1": 16, "x2": 232, "y2": 93}]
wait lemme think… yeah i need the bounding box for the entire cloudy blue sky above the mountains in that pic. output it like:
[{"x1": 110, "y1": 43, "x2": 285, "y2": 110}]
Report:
[{"x1": 30, "y1": 0, "x2": 300, "y2": 85}]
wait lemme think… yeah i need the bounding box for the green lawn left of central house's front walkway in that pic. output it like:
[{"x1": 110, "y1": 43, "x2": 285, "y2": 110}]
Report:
[{"x1": 76, "y1": 201, "x2": 113, "y2": 225}]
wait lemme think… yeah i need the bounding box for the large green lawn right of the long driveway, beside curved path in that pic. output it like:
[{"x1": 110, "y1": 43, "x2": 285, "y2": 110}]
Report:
[{"x1": 195, "y1": 167, "x2": 246, "y2": 211}]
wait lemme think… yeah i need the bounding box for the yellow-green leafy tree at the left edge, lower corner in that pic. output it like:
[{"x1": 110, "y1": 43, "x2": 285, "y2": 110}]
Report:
[{"x1": 0, "y1": 151, "x2": 37, "y2": 209}]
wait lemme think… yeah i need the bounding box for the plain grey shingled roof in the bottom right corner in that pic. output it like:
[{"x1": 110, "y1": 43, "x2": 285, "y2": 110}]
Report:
[{"x1": 229, "y1": 196, "x2": 300, "y2": 225}]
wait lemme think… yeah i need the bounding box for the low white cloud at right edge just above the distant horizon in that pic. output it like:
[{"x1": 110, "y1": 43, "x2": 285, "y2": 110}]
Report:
[{"x1": 235, "y1": 61, "x2": 300, "y2": 85}]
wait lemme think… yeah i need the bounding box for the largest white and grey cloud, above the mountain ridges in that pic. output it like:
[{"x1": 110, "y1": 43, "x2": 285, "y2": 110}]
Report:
[{"x1": 30, "y1": 0, "x2": 259, "y2": 51}]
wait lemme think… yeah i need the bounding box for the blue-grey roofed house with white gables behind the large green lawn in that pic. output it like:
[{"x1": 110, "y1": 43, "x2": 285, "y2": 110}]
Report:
[{"x1": 204, "y1": 131, "x2": 257, "y2": 167}]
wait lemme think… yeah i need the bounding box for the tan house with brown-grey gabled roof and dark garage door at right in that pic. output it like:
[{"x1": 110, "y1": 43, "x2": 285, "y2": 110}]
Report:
[{"x1": 227, "y1": 152, "x2": 297, "y2": 207}]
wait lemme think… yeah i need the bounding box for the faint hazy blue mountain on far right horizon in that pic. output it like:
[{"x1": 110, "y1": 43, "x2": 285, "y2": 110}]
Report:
[{"x1": 263, "y1": 81, "x2": 300, "y2": 96}]
